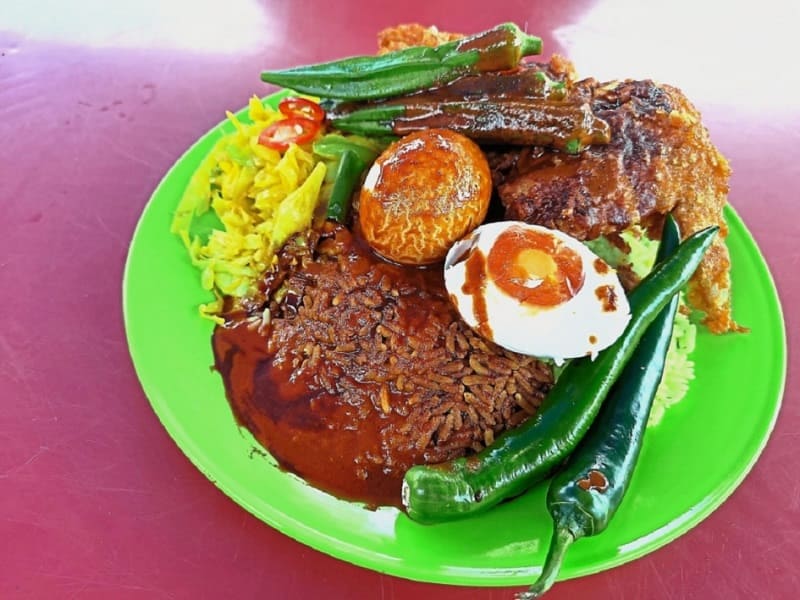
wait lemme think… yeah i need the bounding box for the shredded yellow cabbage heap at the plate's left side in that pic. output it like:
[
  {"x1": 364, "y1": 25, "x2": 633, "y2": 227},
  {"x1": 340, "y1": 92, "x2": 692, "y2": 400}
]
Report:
[{"x1": 171, "y1": 97, "x2": 325, "y2": 321}]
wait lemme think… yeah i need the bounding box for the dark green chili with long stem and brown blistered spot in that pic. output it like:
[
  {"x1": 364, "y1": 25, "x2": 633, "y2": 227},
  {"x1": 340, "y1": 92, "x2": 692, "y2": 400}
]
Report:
[{"x1": 517, "y1": 216, "x2": 680, "y2": 600}]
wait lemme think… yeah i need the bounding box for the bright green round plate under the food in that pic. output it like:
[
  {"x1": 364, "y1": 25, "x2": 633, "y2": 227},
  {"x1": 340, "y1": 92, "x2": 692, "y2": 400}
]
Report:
[{"x1": 123, "y1": 97, "x2": 786, "y2": 586}]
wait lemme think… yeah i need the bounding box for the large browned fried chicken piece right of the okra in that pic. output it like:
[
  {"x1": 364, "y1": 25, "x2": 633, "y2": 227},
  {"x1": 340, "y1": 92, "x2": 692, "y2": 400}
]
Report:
[{"x1": 492, "y1": 79, "x2": 740, "y2": 333}]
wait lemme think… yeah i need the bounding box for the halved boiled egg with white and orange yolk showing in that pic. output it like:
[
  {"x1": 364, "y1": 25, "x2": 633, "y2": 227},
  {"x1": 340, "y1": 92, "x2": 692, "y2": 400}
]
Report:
[{"x1": 444, "y1": 221, "x2": 630, "y2": 364}]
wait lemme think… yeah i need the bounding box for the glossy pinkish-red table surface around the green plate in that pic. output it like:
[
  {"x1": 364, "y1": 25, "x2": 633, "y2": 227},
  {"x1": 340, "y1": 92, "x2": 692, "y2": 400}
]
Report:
[{"x1": 0, "y1": 0, "x2": 800, "y2": 600}]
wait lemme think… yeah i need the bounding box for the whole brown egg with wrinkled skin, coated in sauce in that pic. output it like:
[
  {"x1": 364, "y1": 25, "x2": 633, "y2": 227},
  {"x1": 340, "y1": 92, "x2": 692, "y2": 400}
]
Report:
[{"x1": 358, "y1": 129, "x2": 492, "y2": 265}]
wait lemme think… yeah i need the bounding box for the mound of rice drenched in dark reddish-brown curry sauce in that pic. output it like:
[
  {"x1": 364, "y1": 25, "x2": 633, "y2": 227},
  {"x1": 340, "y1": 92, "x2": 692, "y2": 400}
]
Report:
[{"x1": 213, "y1": 227, "x2": 552, "y2": 506}]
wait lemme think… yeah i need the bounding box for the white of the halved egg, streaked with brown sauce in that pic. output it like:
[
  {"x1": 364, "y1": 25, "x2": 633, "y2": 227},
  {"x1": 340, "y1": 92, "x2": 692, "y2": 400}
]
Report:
[{"x1": 444, "y1": 221, "x2": 630, "y2": 364}]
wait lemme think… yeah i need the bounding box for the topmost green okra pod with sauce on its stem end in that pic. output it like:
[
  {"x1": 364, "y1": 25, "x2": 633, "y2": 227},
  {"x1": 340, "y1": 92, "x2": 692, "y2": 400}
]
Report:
[{"x1": 261, "y1": 23, "x2": 542, "y2": 100}]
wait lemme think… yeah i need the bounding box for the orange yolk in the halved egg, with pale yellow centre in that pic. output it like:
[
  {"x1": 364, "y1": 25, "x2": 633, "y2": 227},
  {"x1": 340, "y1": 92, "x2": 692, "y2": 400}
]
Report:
[{"x1": 487, "y1": 227, "x2": 584, "y2": 307}]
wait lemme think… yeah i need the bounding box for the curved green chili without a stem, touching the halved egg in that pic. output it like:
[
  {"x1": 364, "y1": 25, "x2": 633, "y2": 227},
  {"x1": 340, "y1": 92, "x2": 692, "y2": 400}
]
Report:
[{"x1": 402, "y1": 227, "x2": 719, "y2": 523}]
